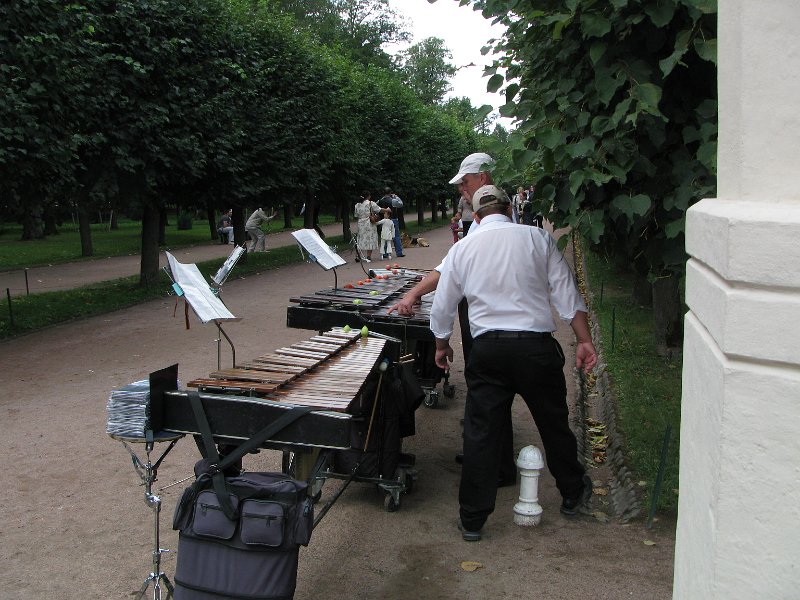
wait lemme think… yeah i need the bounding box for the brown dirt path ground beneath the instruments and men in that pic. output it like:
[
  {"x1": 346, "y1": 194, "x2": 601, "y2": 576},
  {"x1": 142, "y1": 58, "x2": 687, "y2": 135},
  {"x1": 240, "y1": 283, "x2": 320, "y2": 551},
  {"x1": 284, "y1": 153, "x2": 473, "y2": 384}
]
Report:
[{"x1": 0, "y1": 223, "x2": 674, "y2": 600}]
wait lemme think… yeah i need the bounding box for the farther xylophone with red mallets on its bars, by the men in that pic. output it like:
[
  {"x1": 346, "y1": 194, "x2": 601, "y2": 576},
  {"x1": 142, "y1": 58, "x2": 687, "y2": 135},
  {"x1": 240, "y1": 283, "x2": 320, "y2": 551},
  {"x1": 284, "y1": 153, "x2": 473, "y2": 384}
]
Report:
[{"x1": 286, "y1": 267, "x2": 454, "y2": 408}]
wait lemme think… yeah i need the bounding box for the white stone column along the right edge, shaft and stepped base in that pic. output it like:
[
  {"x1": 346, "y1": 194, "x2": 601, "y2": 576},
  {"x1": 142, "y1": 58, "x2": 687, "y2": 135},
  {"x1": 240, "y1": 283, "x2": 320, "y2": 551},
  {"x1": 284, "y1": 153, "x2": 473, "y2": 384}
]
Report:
[{"x1": 673, "y1": 0, "x2": 800, "y2": 600}]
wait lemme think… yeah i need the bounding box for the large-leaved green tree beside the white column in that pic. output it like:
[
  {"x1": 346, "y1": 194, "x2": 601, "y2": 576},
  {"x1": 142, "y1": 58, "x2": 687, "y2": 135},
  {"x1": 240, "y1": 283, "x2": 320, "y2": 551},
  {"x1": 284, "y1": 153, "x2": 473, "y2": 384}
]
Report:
[{"x1": 472, "y1": 0, "x2": 717, "y2": 352}]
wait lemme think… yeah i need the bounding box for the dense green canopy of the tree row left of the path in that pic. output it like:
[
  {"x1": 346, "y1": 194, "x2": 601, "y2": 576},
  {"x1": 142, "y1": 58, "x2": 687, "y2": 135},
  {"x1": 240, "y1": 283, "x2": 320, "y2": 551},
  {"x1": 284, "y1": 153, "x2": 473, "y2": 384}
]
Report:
[{"x1": 0, "y1": 0, "x2": 494, "y2": 285}]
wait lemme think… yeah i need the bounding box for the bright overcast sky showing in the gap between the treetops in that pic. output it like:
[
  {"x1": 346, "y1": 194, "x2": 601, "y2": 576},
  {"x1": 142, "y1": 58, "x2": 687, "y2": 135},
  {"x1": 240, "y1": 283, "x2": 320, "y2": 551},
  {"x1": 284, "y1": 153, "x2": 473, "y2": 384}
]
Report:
[{"x1": 386, "y1": 0, "x2": 510, "y2": 128}]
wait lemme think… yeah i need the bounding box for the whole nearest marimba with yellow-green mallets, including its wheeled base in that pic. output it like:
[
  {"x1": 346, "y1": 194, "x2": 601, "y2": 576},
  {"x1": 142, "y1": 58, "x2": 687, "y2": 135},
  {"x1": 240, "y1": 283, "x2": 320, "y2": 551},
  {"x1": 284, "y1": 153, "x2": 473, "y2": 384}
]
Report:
[{"x1": 145, "y1": 328, "x2": 416, "y2": 508}]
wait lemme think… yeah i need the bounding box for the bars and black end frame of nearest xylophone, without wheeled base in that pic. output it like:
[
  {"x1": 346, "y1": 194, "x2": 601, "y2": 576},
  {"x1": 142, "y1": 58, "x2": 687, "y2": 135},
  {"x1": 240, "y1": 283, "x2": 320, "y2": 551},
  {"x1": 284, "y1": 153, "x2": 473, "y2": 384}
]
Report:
[{"x1": 151, "y1": 328, "x2": 399, "y2": 449}]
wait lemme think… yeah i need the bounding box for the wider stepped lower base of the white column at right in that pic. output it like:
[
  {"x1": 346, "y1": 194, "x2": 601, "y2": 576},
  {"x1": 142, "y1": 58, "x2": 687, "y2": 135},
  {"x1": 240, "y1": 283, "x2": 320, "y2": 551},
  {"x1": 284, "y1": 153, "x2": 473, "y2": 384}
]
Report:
[{"x1": 673, "y1": 200, "x2": 800, "y2": 600}]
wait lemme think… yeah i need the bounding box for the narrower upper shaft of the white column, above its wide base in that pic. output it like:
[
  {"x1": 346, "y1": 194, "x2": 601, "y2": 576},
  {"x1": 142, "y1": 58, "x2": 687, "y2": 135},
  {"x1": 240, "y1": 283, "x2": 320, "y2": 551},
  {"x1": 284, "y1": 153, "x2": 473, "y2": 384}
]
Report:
[{"x1": 718, "y1": 0, "x2": 800, "y2": 201}]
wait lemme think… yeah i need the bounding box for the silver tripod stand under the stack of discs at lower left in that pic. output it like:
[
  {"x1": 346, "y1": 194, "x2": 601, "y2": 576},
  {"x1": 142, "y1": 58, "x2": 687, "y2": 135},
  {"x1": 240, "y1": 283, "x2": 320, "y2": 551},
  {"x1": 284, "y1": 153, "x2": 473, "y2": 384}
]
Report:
[{"x1": 111, "y1": 429, "x2": 183, "y2": 600}]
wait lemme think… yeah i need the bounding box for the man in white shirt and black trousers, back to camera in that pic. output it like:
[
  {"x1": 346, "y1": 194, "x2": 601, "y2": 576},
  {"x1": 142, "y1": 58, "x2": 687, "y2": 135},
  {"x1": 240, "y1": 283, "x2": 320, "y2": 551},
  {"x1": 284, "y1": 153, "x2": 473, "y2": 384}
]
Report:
[{"x1": 431, "y1": 185, "x2": 597, "y2": 541}]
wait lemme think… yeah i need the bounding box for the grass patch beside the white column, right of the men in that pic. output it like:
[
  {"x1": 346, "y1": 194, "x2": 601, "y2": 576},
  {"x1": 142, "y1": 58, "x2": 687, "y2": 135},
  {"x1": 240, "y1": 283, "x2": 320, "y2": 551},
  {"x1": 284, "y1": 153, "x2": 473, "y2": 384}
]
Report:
[{"x1": 585, "y1": 252, "x2": 682, "y2": 514}]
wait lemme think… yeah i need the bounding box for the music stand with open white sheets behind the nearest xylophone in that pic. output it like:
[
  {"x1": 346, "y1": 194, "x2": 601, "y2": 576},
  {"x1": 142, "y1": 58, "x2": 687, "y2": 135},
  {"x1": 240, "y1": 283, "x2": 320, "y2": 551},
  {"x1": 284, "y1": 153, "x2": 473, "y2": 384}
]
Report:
[{"x1": 165, "y1": 246, "x2": 244, "y2": 369}]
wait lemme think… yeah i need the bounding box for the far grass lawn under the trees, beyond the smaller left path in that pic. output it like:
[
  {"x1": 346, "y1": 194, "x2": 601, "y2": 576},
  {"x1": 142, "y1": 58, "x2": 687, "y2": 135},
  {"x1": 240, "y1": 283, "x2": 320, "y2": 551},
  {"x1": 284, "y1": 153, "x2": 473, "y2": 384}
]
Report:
[{"x1": 0, "y1": 215, "x2": 334, "y2": 271}]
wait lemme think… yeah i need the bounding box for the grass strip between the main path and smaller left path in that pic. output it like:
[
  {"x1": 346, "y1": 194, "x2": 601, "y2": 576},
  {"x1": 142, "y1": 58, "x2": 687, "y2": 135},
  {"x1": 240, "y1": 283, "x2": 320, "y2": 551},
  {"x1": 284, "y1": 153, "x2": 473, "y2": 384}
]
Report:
[{"x1": 0, "y1": 221, "x2": 441, "y2": 339}]
